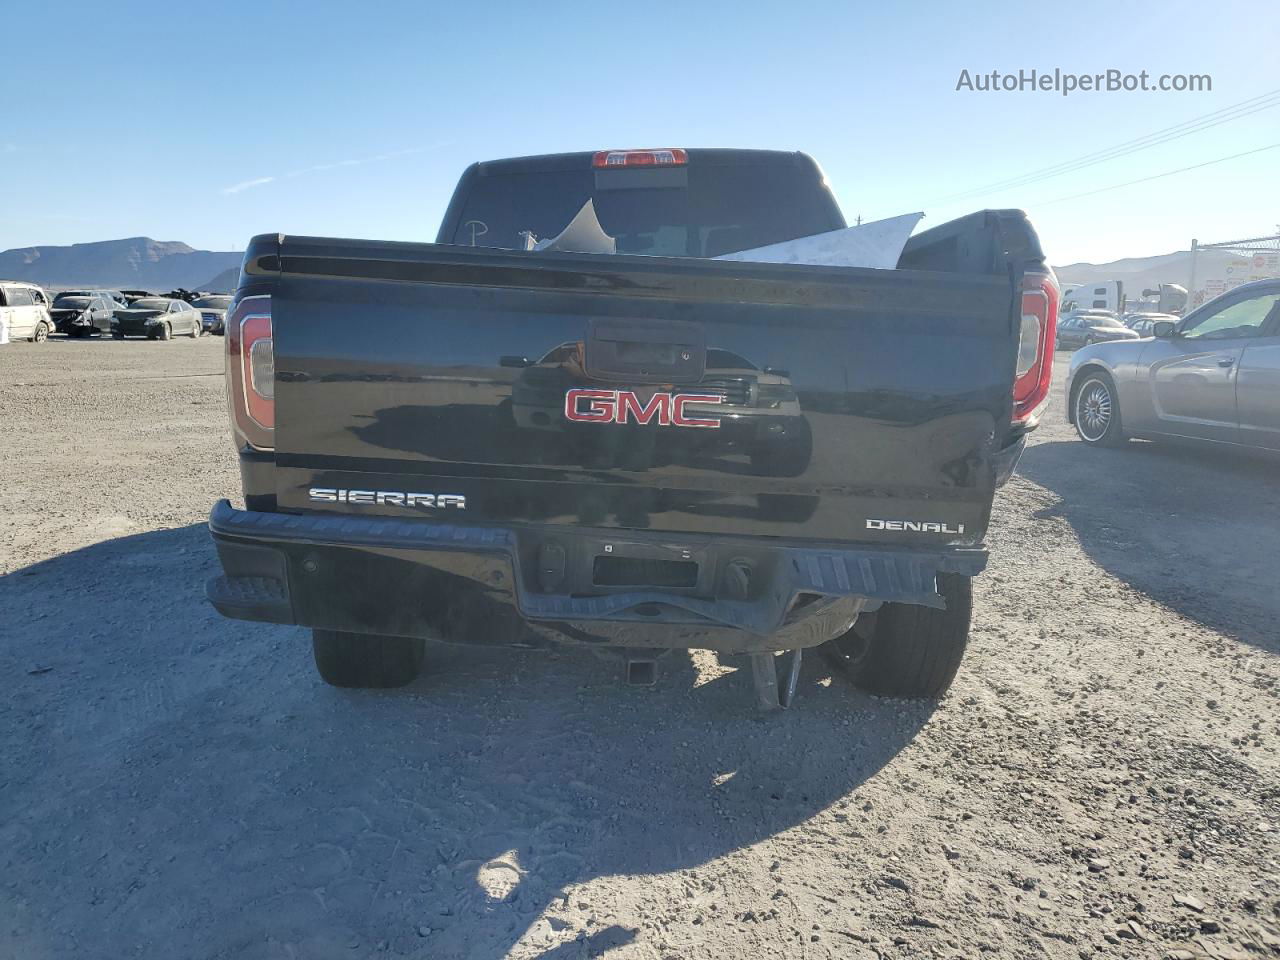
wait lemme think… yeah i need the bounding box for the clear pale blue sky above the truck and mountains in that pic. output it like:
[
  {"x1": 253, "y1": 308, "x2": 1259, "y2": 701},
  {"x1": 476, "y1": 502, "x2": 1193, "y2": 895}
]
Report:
[{"x1": 0, "y1": 0, "x2": 1280, "y2": 265}]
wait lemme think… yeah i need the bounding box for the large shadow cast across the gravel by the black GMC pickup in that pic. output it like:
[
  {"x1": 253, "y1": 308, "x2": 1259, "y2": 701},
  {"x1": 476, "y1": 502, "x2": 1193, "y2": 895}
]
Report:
[{"x1": 0, "y1": 527, "x2": 931, "y2": 960}]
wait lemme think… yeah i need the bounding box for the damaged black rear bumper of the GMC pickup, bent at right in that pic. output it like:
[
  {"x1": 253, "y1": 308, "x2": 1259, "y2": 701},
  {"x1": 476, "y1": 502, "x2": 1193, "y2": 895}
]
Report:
[{"x1": 207, "y1": 500, "x2": 987, "y2": 653}]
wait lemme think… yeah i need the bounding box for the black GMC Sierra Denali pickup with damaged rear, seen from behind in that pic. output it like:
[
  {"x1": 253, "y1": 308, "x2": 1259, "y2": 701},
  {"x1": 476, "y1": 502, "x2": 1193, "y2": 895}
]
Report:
[{"x1": 207, "y1": 150, "x2": 1057, "y2": 707}]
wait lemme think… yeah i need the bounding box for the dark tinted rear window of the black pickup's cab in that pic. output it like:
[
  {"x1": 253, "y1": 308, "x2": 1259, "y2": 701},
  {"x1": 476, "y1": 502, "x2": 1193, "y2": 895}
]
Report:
[{"x1": 453, "y1": 161, "x2": 845, "y2": 257}]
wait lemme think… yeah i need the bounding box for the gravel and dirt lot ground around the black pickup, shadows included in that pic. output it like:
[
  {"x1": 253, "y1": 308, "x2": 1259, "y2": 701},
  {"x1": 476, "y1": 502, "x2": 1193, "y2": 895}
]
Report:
[{"x1": 0, "y1": 338, "x2": 1280, "y2": 960}]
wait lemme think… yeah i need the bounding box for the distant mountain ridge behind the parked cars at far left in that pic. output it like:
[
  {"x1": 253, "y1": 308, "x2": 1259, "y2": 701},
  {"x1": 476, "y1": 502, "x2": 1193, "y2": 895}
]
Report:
[{"x1": 0, "y1": 237, "x2": 243, "y2": 291}]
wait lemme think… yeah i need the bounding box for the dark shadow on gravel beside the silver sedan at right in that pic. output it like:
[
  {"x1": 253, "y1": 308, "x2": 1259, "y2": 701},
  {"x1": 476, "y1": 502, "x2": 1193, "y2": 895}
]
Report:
[{"x1": 1018, "y1": 440, "x2": 1280, "y2": 652}]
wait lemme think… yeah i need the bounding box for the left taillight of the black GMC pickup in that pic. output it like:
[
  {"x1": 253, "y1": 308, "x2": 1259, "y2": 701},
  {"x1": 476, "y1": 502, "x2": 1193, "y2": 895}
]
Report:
[{"x1": 225, "y1": 297, "x2": 275, "y2": 451}]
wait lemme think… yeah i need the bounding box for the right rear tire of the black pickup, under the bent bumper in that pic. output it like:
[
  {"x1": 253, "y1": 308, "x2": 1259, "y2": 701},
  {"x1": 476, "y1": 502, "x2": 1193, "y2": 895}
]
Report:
[{"x1": 831, "y1": 573, "x2": 973, "y2": 699}]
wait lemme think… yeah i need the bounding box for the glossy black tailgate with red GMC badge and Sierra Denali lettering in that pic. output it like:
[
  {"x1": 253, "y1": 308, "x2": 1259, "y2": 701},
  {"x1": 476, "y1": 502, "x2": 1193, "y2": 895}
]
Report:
[{"x1": 271, "y1": 237, "x2": 1019, "y2": 544}]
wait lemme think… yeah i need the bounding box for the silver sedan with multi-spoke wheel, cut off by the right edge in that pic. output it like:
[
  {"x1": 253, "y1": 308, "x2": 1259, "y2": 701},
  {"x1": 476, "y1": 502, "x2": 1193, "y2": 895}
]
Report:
[{"x1": 1066, "y1": 280, "x2": 1280, "y2": 451}]
